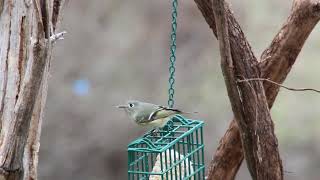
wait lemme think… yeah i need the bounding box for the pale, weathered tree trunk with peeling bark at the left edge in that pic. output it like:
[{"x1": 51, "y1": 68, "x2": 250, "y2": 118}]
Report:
[{"x1": 0, "y1": 0, "x2": 62, "y2": 179}]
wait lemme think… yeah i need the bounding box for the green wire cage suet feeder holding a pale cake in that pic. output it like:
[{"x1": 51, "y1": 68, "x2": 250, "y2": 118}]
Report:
[{"x1": 128, "y1": 115, "x2": 205, "y2": 180}]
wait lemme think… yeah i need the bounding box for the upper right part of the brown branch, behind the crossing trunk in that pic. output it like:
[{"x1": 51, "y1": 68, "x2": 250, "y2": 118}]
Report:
[{"x1": 259, "y1": 0, "x2": 320, "y2": 107}]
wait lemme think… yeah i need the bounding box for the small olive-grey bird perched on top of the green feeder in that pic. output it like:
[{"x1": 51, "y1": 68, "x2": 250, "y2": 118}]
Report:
[{"x1": 117, "y1": 100, "x2": 190, "y2": 129}]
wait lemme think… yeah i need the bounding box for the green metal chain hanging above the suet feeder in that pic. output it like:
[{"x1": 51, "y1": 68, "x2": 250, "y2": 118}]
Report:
[{"x1": 168, "y1": 0, "x2": 178, "y2": 108}]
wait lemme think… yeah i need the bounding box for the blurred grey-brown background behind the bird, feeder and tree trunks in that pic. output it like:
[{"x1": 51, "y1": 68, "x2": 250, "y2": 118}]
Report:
[{"x1": 39, "y1": 0, "x2": 320, "y2": 180}]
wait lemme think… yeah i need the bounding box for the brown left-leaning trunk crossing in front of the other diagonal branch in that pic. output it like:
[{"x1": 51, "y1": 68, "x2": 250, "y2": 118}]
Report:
[{"x1": 213, "y1": 0, "x2": 283, "y2": 180}]
